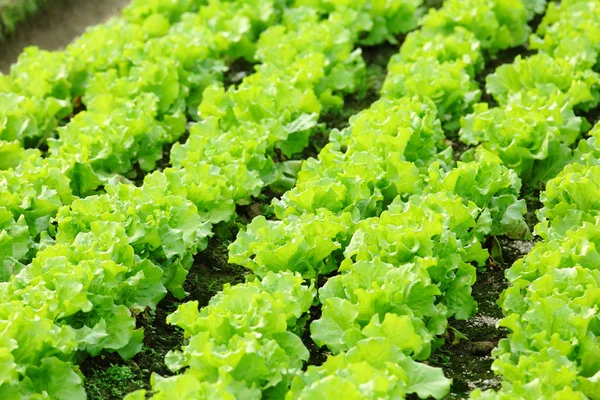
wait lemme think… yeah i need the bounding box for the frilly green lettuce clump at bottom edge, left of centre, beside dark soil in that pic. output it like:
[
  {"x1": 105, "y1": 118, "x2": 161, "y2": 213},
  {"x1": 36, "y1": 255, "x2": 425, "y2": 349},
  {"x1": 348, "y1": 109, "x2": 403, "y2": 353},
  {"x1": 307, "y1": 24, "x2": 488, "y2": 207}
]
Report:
[{"x1": 128, "y1": 272, "x2": 315, "y2": 399}]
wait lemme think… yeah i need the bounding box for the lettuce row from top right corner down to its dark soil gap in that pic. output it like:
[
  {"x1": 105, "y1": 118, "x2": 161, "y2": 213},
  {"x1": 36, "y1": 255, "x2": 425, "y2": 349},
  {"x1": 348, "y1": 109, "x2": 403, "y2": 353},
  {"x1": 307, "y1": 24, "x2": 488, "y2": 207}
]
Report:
[{"x1": 459, "y1": 0, "x2": 600, "y2": 187}]
